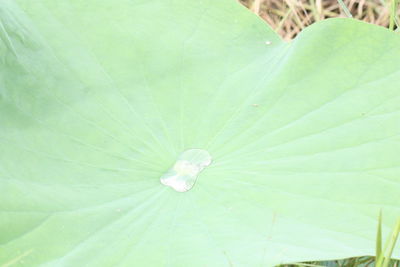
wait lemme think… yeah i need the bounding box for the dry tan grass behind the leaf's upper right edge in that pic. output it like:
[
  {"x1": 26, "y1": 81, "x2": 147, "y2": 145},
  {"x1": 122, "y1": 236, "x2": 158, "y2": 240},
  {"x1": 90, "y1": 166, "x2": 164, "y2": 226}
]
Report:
[{"x1": 239, "y1": 0, "x2": 400, "y2": 40}]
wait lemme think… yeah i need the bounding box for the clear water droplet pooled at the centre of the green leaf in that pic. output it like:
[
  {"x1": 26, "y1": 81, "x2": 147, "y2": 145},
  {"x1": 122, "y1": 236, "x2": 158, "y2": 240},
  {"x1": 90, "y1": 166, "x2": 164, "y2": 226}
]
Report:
[{"x1": 160, "y1": 149, "x2": 212, "y2": 192}]
